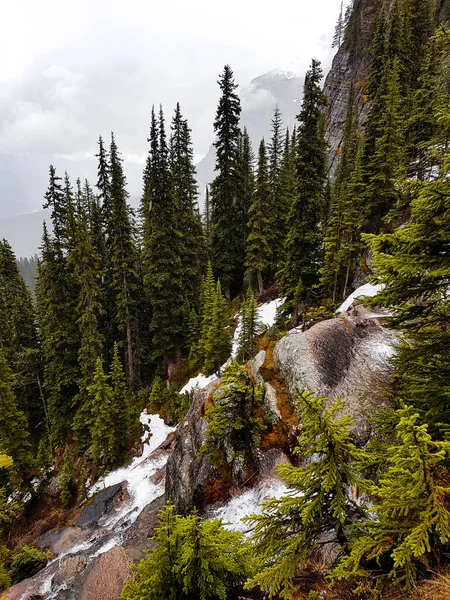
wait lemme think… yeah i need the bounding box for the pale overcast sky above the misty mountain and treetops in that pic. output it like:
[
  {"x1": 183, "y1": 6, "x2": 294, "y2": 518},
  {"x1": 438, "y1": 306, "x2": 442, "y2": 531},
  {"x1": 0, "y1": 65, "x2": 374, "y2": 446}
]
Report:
[{"x1": 0, "y1": 0, "x2": 340, "y2": 171}]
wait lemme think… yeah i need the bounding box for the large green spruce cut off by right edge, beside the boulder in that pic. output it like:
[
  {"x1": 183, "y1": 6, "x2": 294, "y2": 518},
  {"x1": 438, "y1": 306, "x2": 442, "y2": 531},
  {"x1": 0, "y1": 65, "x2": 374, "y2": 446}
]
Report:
[{"x1": 368, "y1": 139, "x2": 450, "y2": 435}]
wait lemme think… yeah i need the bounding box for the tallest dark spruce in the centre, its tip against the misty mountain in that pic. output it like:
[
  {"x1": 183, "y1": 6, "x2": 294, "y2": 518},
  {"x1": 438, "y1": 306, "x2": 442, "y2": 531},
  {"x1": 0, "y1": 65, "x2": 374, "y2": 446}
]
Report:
[{"x1": 210, "y1": 65, "x2": 245, "y2": 297}]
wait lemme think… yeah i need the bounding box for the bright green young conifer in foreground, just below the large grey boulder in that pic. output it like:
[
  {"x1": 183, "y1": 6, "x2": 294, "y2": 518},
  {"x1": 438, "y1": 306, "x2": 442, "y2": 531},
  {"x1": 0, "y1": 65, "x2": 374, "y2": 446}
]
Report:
[{"x1": 246, "y1": 392, "x2": 362, "y2": 599}]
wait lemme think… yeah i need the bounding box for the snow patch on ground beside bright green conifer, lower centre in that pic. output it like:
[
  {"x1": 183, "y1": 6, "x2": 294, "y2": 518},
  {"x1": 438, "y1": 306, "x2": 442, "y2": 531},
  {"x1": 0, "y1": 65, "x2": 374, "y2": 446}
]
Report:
[{"x1": 212, "y1": 478, "x2": 288, "y2": 531}]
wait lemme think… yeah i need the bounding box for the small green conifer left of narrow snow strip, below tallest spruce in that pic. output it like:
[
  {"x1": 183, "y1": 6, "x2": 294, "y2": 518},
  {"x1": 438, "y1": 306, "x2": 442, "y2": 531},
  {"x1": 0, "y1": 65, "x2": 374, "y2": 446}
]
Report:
[{"x1": 203, "y1": 280, "x2": 231, "y2": 375}]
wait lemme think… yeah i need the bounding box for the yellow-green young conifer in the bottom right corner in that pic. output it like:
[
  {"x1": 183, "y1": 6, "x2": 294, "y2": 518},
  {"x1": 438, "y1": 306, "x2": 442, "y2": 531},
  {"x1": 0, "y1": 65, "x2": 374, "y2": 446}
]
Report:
[{"x1": 334, "y1": 406, "x2": 450, "y2": 587}]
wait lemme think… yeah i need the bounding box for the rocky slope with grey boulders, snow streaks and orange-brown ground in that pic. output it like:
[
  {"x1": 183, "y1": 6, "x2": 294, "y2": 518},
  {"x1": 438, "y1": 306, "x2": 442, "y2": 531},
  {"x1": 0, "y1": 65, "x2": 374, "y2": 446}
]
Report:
[{"x1": 5, "y1": 289, "x2": 396, "y2": 600}]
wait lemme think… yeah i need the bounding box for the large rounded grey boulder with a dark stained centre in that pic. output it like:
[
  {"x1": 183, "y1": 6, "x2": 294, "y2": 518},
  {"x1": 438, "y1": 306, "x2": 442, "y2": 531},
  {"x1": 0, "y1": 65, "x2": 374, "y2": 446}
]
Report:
[{"x1": 274, "y1": 307, "x2": 396, "y2": 443}]
